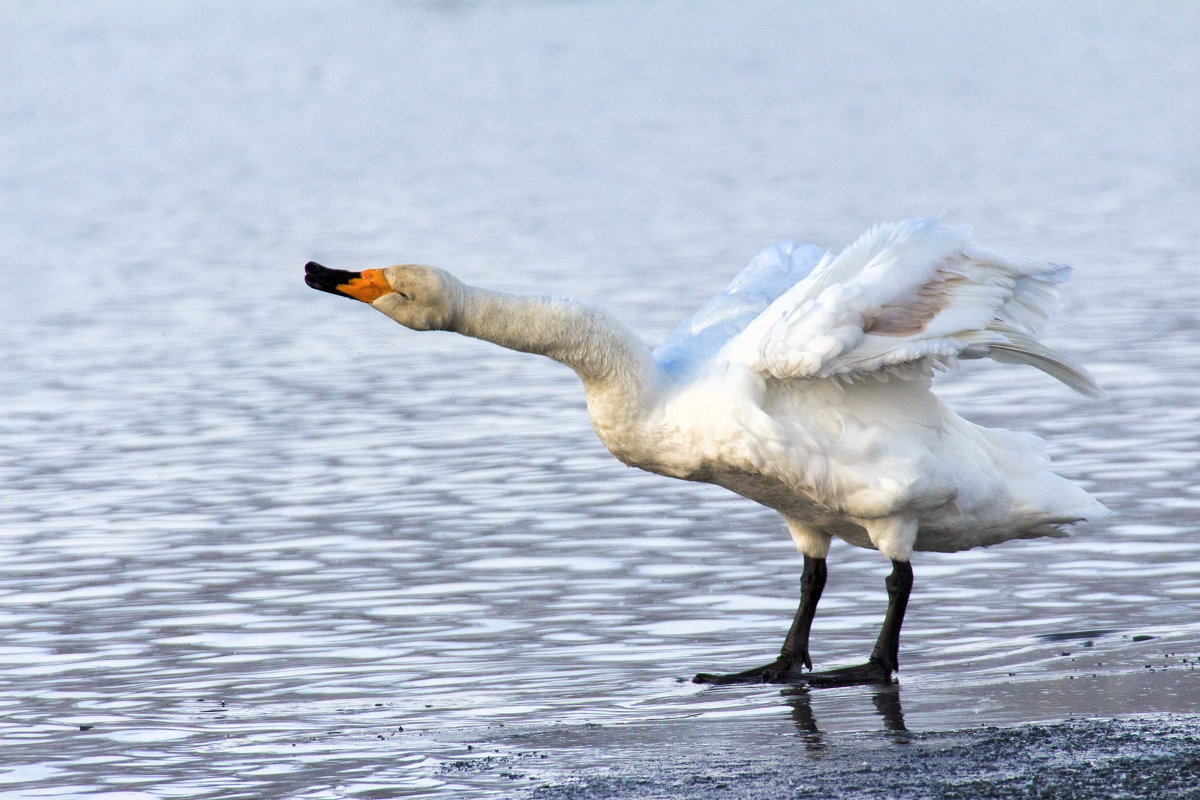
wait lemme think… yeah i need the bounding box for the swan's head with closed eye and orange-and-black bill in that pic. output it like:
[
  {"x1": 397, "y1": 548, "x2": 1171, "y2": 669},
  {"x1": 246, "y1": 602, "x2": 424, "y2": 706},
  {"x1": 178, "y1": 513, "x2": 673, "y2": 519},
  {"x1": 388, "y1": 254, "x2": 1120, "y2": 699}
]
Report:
[{"x1": 305, "y1": 261, "x2": 462, "y2": 331}]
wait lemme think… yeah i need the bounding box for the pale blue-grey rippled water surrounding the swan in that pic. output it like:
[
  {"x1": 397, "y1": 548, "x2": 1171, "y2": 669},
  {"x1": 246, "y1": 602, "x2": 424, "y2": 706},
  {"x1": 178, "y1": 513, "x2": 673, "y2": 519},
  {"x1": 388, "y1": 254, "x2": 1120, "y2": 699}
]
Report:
[{"x1": 0, "y1": 1, "x2": 1200, "y2": 798}]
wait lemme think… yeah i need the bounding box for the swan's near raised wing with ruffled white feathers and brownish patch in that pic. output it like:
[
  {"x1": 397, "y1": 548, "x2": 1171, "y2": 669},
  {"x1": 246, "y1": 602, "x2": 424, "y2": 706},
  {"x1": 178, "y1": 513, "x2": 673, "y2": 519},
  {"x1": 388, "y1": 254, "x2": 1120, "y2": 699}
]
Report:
[{"x1": 720, "y1": 219, "x2": 1099, "y2": 395}]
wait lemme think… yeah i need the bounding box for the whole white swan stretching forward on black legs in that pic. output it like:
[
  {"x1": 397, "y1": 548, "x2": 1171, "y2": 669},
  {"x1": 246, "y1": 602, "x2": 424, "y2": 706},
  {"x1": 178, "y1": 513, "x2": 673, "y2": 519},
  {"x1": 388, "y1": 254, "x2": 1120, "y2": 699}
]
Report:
[{"x1": 306, "y1": 219, "x2": 1106, "y2": 685}]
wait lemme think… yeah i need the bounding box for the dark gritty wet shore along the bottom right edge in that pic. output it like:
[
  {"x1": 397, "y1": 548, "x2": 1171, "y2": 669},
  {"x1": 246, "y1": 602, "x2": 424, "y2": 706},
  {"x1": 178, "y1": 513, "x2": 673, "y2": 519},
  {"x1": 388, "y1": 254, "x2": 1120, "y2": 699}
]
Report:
[{"x1": 442, "y1": 715, "x2": 1200, "y2": 800}]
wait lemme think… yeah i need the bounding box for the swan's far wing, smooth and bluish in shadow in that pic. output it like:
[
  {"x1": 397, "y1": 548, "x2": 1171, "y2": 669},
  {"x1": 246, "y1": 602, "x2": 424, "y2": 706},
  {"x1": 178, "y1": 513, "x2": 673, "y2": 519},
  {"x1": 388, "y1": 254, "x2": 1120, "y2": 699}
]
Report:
[{"x1": 654, "y1": 241, "x2": 821, "y2": 373}]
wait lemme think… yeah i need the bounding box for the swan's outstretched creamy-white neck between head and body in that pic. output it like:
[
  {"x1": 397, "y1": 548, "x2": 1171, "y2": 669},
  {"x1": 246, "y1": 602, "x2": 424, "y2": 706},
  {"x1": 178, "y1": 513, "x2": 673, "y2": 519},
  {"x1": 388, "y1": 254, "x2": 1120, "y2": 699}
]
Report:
[{"x1": 449, "y1": 285, "x2": 659, "y2": 424}]
